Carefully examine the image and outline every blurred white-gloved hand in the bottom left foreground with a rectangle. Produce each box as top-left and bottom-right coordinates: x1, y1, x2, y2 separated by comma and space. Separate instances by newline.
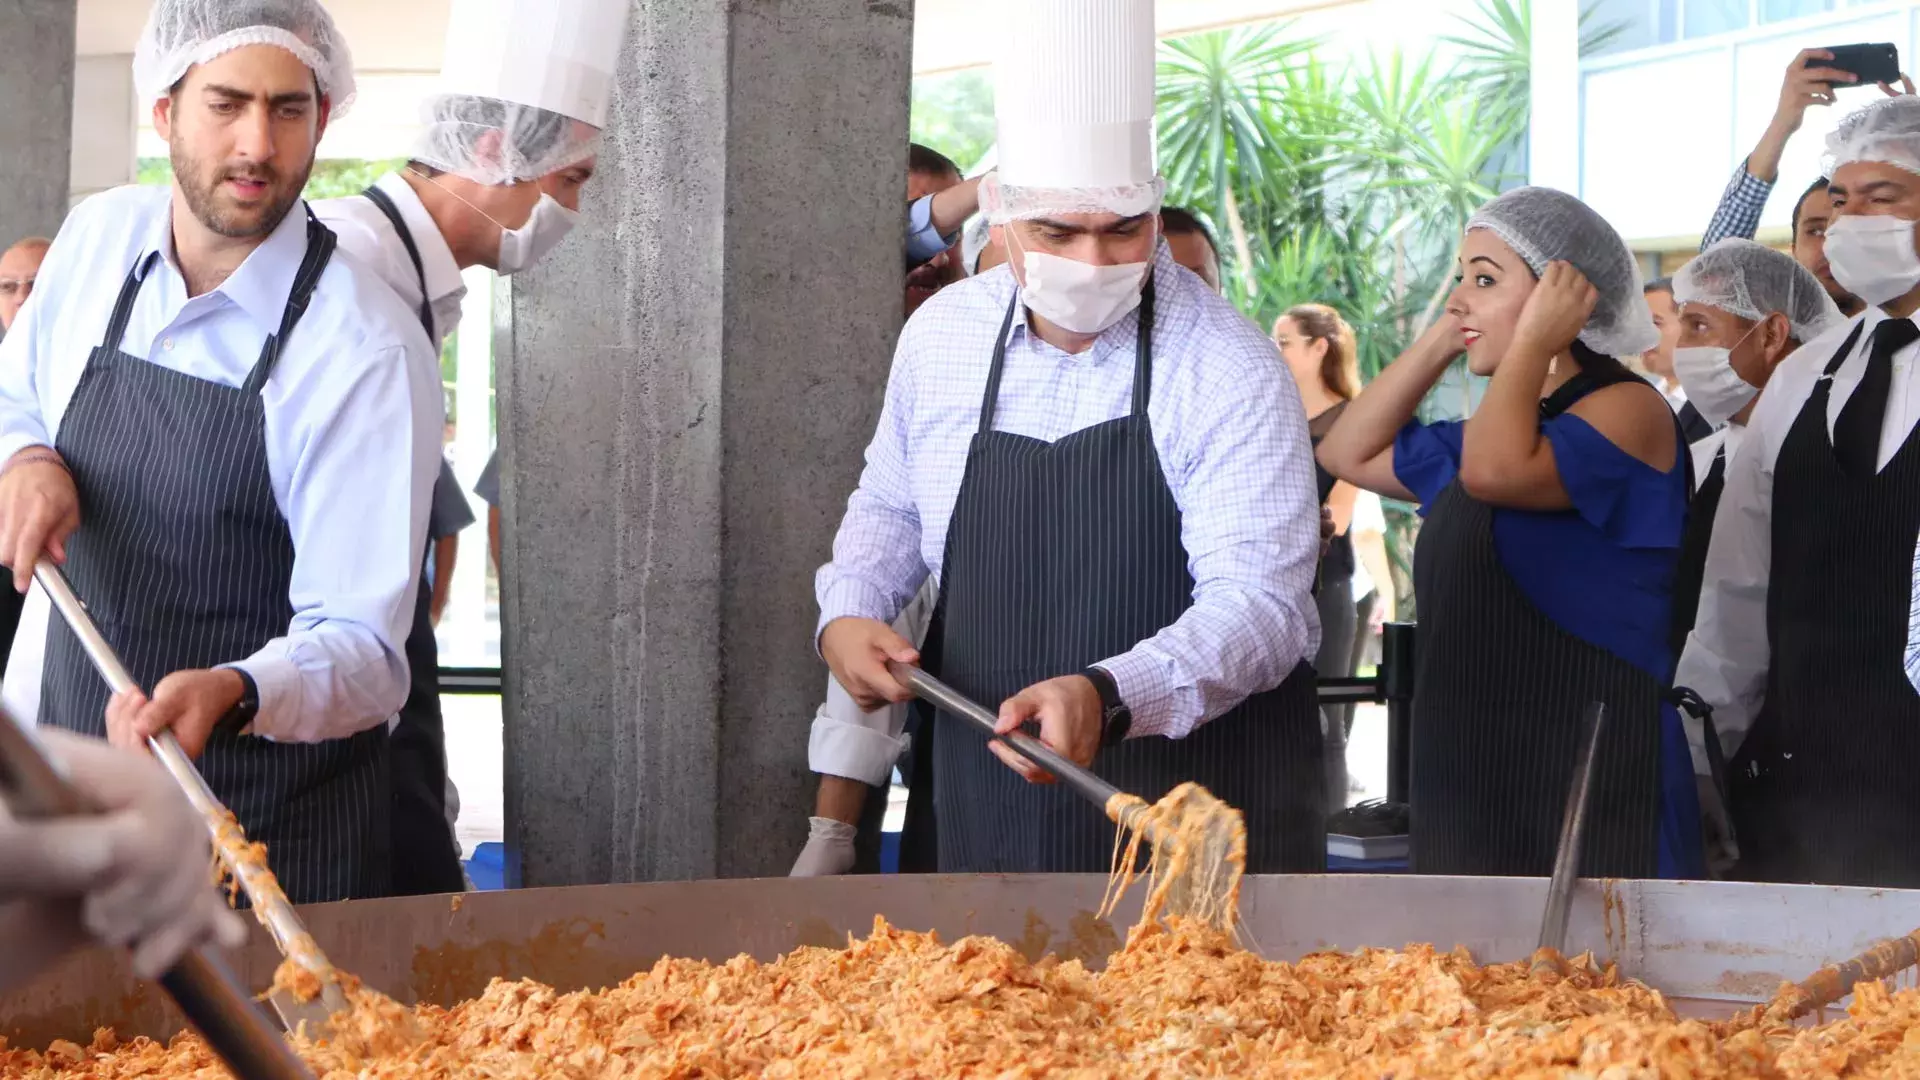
0, 728, 246, 978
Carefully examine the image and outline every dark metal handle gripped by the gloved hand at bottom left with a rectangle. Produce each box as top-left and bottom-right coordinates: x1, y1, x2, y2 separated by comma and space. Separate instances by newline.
0, 709, 313, 1080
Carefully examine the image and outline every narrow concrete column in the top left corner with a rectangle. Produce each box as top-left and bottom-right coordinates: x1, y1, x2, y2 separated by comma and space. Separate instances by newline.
0, 0, 77, 248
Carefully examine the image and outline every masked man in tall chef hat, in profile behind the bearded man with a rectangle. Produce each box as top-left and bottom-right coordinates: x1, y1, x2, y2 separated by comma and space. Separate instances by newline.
313, 0, 628, 896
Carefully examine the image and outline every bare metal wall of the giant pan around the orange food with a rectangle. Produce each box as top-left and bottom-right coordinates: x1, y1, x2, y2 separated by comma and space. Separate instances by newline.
0, 874, 1920, 1047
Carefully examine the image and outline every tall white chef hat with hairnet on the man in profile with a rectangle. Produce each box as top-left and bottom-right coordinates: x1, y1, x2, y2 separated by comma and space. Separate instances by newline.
413, 0, 630, 184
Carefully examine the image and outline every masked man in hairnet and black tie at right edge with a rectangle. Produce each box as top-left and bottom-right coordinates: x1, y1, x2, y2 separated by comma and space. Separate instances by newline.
1674, 96, 1920, 888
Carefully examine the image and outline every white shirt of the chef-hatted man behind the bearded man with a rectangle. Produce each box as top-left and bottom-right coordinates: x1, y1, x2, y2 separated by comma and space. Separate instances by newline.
313, 173, 467, 343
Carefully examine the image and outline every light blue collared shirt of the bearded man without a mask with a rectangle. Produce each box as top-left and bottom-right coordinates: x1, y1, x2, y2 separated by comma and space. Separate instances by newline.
0, 186, 445, 742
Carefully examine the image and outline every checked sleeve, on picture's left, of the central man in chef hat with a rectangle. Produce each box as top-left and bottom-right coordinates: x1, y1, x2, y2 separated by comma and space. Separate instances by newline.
814, 321, 927, 642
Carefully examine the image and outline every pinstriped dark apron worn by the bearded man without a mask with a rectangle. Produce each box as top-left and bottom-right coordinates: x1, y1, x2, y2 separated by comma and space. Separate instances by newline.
40, 213, 388, 903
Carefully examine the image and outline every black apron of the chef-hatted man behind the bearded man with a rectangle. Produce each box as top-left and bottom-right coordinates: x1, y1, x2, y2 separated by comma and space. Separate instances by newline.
361, 188, 467, 896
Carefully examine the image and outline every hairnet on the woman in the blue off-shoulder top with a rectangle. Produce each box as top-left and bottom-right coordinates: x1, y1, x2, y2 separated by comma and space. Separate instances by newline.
1467, 188, 1661, 356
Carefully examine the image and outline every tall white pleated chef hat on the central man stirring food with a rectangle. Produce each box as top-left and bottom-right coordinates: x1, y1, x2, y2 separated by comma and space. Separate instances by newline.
981, 0, 1165, 225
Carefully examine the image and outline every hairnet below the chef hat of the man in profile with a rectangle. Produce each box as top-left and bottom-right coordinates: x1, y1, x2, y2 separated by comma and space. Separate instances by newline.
413, 94, 599, 184
